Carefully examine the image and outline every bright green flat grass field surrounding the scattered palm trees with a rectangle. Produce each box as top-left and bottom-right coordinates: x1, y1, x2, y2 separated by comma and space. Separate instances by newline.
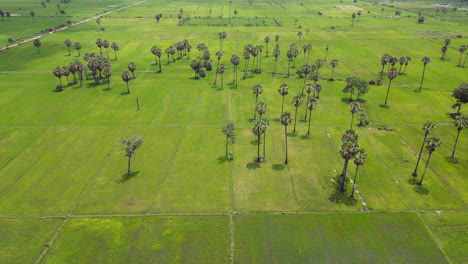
0, 0, 468, 264
